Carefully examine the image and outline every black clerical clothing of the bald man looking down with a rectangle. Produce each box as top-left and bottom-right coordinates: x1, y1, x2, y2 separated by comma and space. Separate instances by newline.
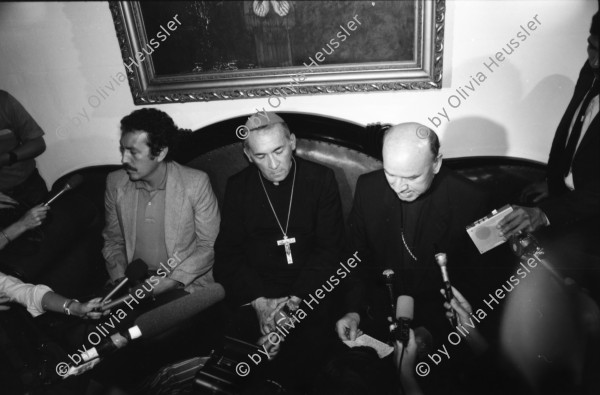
346, 166, 495, 344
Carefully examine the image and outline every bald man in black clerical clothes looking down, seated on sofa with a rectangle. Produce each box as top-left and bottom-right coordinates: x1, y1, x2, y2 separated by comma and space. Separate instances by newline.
336, 123, 487, 341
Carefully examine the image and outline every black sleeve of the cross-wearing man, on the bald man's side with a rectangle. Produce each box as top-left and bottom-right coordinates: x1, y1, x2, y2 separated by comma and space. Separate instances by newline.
290, 169, 344, 298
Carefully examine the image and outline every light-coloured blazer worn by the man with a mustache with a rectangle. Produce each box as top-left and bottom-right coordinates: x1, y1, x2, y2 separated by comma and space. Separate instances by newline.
102, 162, 221, 292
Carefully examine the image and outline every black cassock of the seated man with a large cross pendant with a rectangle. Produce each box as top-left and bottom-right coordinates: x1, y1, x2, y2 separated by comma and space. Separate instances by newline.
214, 157, 343, 390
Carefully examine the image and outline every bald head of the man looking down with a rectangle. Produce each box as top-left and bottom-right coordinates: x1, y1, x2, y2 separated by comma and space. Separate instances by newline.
383, 122, 442, 202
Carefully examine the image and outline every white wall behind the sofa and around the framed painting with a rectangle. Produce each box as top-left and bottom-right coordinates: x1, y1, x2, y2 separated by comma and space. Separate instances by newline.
0, 0, 597, 184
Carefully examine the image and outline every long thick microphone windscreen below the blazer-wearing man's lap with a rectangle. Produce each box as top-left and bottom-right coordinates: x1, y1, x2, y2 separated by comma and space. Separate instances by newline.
135, 283, 225, 337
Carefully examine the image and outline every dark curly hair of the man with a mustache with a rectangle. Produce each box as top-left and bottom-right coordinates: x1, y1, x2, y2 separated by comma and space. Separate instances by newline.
121, 108, 190, 160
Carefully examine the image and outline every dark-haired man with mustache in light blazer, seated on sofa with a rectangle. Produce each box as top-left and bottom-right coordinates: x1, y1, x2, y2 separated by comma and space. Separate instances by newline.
102, 108, 220, 295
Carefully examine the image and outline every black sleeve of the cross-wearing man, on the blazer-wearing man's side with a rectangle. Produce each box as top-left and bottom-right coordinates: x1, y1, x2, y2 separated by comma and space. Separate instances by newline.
213, 179, 264, 306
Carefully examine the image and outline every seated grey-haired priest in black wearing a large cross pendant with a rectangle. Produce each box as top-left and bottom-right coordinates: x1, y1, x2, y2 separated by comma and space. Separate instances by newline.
214, 112, 343, 392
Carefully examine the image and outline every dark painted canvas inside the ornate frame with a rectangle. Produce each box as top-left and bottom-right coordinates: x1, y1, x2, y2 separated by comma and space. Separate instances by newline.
140, 1, 417, 76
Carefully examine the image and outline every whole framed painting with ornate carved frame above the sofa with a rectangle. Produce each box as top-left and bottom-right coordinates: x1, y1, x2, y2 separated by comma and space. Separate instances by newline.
109, 0, 445, 105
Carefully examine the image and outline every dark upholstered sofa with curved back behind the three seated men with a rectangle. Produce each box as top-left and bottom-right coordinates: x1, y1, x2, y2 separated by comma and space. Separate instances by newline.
54, 113, 544, 296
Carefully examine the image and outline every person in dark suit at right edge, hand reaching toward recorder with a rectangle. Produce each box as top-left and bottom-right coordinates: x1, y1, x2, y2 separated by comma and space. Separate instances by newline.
499, 9, 600, 248
